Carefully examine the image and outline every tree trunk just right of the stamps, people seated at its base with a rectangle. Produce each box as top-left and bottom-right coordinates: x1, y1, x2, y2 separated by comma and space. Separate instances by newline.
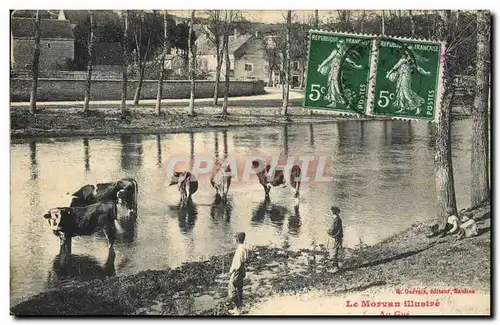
434, 11, 457, 230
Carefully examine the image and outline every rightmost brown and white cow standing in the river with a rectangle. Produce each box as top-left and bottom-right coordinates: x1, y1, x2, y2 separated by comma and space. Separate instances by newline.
252, 160, 302, 206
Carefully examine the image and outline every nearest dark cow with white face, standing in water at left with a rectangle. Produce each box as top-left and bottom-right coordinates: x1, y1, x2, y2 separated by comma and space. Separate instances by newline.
43, 202, 122, 255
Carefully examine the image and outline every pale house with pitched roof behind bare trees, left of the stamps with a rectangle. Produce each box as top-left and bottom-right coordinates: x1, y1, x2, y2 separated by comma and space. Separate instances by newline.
196, 30, 269, 80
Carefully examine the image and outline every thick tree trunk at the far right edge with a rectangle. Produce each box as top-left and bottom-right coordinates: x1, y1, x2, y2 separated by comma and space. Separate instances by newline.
471, 10, 491, 206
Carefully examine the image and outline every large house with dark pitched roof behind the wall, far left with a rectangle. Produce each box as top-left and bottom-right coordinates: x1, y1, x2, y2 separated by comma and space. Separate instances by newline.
10, 17, 75, 70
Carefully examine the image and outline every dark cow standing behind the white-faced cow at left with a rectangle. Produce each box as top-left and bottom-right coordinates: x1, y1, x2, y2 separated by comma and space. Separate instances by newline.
70, 178, 138, 213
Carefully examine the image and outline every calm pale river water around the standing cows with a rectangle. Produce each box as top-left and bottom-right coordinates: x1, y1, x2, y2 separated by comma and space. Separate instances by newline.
11, 120, 472, 303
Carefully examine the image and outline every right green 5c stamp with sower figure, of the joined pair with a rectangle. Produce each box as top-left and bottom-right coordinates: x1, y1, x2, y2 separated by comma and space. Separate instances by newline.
371, 38, 444, 120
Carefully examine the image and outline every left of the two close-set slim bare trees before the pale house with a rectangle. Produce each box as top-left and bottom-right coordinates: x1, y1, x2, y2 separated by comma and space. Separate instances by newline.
205, 10, 224, 106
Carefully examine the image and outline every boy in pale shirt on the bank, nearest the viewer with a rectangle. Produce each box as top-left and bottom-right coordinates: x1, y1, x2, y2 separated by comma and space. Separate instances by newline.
228, 232, 247, 315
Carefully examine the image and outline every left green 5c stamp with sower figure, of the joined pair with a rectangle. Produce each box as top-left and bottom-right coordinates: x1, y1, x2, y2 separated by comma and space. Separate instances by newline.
304, 31, 372, 114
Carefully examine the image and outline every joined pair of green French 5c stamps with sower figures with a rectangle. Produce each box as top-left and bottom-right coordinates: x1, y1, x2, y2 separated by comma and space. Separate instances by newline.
304, 31, 445, 120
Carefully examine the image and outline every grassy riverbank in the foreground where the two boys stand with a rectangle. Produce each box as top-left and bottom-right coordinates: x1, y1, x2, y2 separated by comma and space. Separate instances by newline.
11, 203, 491, 315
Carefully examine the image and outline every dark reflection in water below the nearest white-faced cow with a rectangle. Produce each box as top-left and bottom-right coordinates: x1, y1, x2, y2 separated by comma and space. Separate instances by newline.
47, 248, 116, 288
